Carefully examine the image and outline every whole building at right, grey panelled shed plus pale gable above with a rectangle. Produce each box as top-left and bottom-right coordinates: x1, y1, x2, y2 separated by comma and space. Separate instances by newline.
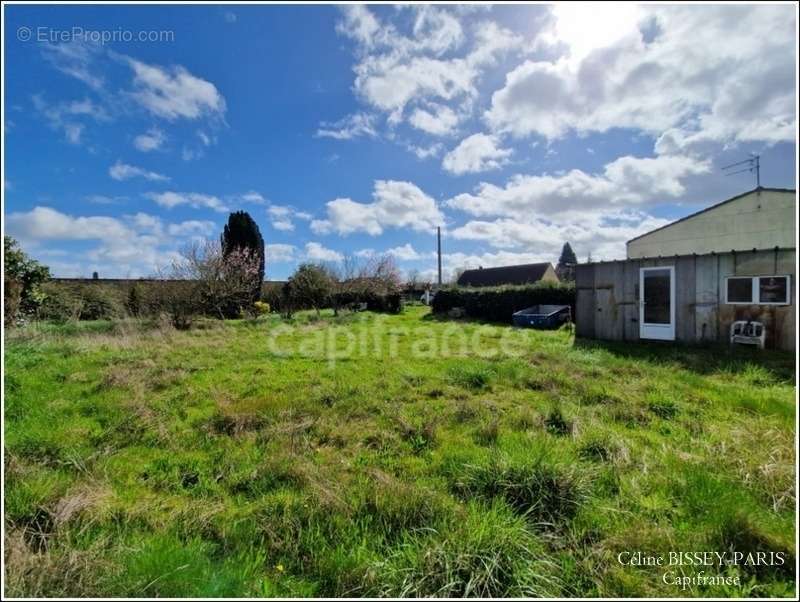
575, 188, 797, 351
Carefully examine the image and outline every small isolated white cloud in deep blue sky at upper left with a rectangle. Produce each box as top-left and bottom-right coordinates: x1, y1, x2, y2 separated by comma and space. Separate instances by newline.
126, 57, 225, 121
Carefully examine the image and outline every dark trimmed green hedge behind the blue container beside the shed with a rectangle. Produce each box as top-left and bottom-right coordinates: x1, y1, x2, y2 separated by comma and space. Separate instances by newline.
432, 283, 575, 322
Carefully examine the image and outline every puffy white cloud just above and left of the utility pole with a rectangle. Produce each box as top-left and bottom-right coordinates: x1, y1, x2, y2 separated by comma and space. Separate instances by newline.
311, 180, 444, 236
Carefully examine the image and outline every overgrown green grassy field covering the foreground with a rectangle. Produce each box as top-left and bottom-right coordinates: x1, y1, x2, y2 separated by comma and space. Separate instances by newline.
5, 307, 796, 597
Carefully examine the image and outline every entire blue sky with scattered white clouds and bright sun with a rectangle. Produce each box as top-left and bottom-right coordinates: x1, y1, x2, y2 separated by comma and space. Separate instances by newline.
3, 3, 797, 280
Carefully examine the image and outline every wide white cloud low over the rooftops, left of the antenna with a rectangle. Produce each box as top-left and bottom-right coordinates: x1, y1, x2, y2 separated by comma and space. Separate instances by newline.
446, 151, 710, 261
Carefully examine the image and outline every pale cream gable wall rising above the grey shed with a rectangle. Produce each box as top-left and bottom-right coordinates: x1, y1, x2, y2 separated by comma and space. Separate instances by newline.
628, 189, 797, 259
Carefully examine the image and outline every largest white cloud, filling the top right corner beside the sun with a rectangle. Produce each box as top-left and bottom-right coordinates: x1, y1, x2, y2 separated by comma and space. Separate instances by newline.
485, 5, 797, 152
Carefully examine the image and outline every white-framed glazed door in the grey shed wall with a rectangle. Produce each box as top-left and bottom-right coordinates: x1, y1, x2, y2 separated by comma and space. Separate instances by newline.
639, 265, 675, 341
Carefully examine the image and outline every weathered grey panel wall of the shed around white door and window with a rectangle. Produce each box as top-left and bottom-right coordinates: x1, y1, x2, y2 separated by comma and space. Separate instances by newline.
575, 249, 797, 351
